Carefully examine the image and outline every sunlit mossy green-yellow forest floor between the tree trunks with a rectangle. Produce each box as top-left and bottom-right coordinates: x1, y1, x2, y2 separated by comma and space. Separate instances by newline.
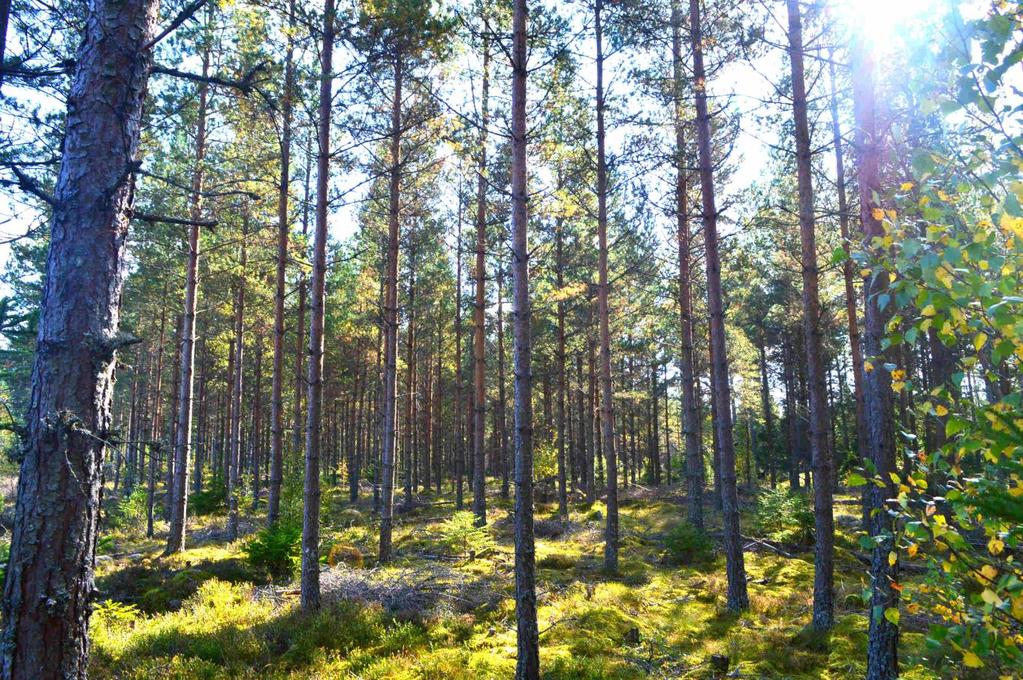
83, 480, 941, 680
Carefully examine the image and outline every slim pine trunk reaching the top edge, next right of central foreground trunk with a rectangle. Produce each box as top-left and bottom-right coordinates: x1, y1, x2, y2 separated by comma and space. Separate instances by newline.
593, 0, 618, 573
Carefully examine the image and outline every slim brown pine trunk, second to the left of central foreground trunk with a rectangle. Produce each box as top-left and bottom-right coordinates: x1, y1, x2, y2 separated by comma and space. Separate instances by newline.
380, 56, 403, 562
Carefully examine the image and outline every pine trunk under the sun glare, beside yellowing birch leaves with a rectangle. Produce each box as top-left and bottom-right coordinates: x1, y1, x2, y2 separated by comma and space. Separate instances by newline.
851, 35, 898, 680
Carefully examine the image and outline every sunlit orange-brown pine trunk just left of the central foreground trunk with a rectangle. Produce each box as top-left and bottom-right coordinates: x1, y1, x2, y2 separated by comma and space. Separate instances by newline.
473, 37, 490, 527
